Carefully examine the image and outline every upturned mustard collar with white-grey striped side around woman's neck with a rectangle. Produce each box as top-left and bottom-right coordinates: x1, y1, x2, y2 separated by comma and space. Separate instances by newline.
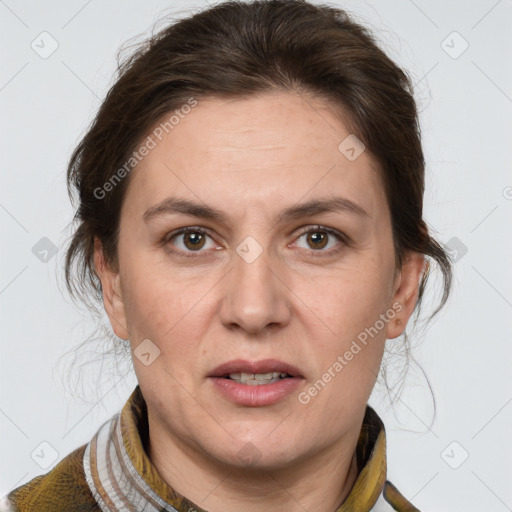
84, 386, 386, 512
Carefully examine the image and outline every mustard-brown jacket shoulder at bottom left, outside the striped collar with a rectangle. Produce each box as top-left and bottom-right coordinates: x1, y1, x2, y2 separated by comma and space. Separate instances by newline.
0, 445, 100, 512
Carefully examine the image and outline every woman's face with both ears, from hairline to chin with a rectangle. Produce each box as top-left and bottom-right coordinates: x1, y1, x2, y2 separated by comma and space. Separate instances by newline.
96, 92, 422, 469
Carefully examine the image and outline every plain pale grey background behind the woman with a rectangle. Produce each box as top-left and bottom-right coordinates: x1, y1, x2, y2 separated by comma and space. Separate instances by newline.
0, 0, 512, 512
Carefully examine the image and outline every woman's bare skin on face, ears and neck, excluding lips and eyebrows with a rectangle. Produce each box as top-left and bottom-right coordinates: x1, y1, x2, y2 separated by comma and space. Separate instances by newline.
95, 92, 424, 512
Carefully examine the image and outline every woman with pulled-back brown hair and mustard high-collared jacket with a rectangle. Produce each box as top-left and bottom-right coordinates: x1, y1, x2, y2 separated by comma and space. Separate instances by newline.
5, 0, 451, 512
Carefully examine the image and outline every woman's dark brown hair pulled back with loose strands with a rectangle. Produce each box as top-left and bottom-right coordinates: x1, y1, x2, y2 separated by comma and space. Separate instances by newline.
65, 0, 452, 336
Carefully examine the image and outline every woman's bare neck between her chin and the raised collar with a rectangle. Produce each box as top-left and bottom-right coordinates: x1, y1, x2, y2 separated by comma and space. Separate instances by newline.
148, 421, 359, 512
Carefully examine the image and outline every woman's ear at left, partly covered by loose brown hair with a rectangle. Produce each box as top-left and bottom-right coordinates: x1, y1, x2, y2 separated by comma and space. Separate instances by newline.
94, 237, 129, 340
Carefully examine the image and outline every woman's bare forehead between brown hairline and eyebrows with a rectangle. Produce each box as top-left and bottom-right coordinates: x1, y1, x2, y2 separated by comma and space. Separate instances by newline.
125, 92, 384, 219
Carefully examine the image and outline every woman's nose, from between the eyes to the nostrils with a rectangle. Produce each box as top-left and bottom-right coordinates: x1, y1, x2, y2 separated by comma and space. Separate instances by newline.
220, 242, 292, 334
